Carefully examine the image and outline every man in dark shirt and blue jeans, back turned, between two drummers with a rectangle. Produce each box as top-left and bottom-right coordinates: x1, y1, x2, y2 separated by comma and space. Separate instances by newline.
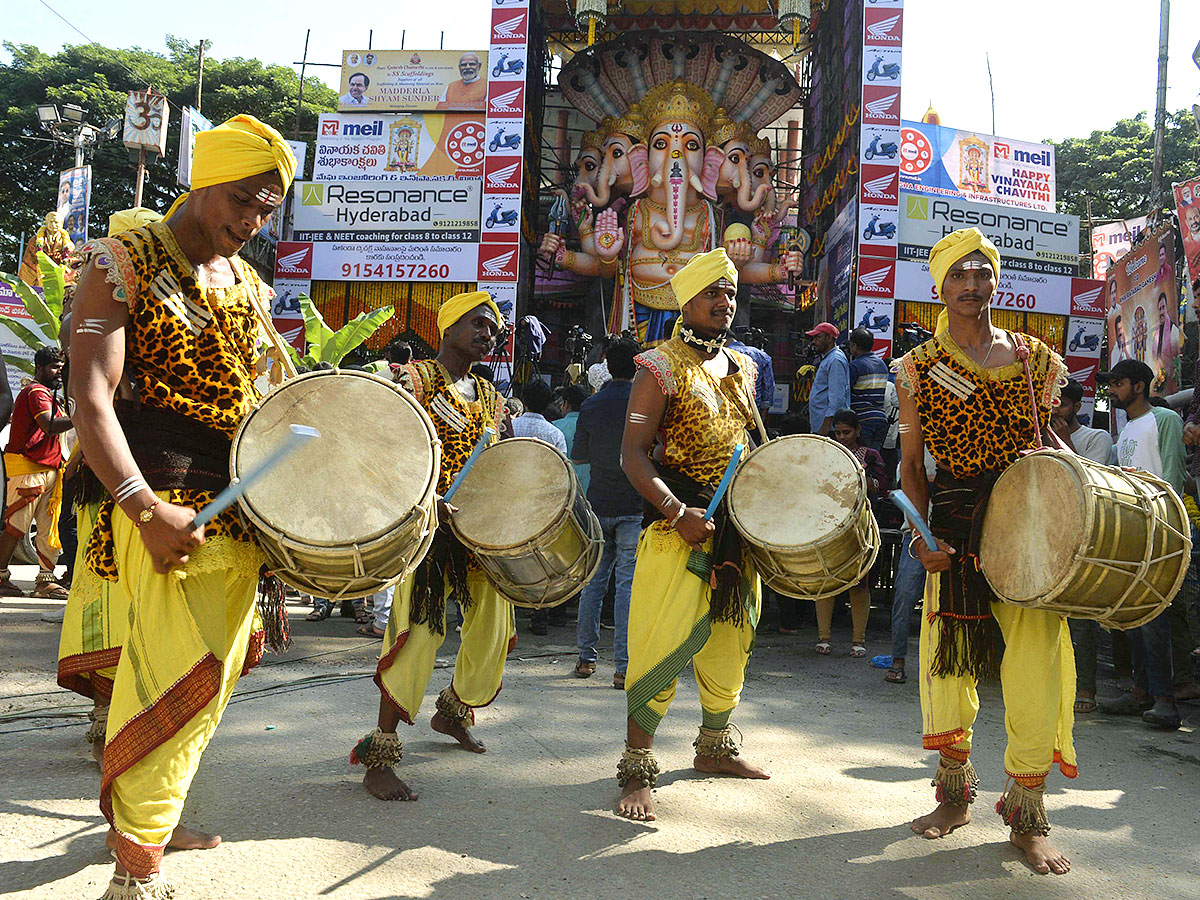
571, 337, 642, 690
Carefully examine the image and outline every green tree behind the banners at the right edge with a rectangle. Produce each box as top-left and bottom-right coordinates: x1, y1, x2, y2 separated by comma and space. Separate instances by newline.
1055, 109, 1200, 230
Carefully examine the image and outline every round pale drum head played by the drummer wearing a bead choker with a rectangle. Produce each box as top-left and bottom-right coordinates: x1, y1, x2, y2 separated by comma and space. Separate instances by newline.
728, 434, 865, 547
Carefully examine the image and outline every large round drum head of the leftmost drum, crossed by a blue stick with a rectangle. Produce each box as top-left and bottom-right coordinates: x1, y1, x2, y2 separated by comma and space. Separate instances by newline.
230, 372, 438, 546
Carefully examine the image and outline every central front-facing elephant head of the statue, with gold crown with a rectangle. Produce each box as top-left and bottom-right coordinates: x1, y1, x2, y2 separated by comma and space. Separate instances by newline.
642, 79, 720, 250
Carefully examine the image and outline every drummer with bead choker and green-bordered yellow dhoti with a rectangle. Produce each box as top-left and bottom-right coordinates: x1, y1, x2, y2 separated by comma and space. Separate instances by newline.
617, 248, 770, 821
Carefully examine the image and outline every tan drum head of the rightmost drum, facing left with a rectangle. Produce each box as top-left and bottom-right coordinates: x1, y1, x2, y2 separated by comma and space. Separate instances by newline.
979, 452, 1088, 601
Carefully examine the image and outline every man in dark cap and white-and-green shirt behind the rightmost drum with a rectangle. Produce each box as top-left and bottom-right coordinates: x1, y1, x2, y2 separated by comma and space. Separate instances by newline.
1102, 359, 1186, 730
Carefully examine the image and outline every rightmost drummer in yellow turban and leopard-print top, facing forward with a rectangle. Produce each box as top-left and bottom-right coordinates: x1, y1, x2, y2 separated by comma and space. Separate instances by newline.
894, 228, 1076, 875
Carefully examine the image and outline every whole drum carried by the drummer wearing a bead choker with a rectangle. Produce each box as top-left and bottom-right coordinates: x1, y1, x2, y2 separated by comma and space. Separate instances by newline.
728, 434, 880, 600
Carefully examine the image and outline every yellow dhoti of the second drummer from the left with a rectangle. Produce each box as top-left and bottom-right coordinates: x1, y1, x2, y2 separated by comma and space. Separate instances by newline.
374, 570, 516, 725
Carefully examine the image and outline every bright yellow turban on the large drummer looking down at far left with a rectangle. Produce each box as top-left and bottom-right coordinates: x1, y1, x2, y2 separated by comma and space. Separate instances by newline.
166, 115, 296, 218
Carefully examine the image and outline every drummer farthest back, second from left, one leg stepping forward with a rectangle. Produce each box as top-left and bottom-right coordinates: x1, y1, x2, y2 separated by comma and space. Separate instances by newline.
350, 290, 516, 800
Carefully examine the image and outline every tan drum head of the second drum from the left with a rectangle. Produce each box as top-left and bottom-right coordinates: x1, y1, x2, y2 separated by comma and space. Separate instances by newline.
452, 438, 575, 550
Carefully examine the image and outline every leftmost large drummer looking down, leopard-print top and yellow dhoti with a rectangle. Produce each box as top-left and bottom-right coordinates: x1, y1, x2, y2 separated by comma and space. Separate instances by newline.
71, 115, 296, 900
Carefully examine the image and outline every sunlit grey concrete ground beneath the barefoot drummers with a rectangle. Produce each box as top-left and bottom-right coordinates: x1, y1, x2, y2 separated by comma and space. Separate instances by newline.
0, 570, 1200, 900
